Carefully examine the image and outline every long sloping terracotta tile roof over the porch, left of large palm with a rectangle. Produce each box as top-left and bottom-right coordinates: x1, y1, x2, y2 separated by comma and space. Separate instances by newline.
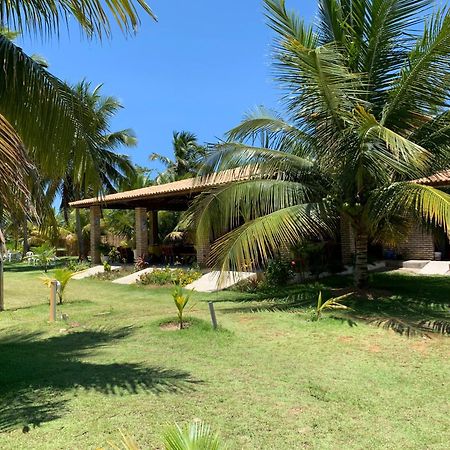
70, 168, 251, 208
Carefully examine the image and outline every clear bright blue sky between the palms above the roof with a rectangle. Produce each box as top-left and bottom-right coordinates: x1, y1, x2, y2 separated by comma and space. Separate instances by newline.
20, 0, 316, 175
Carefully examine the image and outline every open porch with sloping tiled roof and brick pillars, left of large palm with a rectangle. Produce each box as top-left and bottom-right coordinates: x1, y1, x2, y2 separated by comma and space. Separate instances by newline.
70, 170, 244, 266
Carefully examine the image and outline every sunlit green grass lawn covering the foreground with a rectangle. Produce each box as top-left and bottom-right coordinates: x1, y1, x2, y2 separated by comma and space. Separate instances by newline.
0, 271, 450, 449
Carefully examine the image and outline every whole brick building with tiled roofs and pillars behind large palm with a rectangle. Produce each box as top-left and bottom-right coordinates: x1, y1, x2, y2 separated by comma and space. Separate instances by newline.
71, 169, 450, 264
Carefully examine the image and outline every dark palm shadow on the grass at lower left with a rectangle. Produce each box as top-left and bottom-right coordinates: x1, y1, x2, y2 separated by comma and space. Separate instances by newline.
0, 328, 200, 431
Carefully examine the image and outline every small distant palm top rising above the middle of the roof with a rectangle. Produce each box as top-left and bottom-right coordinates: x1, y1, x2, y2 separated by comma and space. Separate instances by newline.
150, 131, 206, 184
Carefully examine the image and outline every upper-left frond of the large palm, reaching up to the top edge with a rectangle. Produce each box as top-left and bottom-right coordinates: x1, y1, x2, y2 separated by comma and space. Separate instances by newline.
266, 0, 365, 128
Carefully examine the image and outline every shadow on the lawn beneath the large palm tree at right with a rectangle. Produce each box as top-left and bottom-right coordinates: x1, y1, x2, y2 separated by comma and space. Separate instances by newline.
222, 273, 450, 336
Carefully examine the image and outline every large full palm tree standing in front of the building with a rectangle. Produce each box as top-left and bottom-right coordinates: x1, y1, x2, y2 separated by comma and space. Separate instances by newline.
188, 0, 450, 287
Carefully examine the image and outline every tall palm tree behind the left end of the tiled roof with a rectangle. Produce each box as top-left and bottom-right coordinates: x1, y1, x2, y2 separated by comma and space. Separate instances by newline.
47, 81, 137, 257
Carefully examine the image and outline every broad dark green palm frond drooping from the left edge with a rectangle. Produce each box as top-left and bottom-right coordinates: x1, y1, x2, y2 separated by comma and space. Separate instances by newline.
0, 35, 102, 182
